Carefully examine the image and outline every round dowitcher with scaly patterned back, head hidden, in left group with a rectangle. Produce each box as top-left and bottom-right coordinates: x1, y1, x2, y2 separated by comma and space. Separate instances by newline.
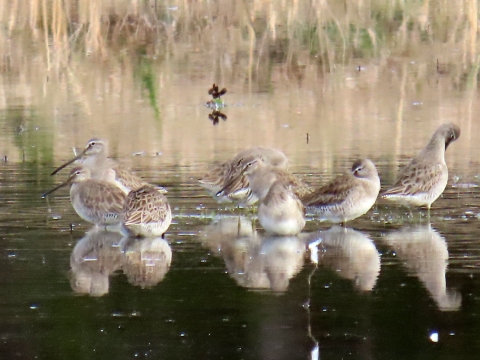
123, 185, 172, 237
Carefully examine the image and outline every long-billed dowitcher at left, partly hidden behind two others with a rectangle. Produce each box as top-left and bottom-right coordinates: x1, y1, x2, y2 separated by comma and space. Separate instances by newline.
51, 138, 147, 194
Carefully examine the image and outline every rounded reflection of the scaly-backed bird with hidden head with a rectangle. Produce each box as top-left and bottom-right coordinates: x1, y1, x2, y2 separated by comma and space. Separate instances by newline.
123, 237, 172, 288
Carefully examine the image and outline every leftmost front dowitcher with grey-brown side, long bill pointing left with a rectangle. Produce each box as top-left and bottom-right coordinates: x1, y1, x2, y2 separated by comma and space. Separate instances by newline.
42, 166, 125, 225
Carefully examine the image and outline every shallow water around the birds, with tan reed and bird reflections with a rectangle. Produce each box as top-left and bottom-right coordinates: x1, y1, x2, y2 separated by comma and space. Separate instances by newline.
0, 1, 480, 359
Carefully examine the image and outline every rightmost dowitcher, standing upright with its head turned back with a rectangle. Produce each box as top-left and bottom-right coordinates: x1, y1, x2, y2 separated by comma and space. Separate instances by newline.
382, 123, 460, 210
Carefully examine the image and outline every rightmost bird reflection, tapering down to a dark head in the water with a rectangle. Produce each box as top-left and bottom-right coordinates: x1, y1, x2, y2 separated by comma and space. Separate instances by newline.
383, 225, 462, 311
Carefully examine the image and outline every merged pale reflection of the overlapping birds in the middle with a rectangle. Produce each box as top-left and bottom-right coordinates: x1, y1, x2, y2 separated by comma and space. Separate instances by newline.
202, 217, 304, 292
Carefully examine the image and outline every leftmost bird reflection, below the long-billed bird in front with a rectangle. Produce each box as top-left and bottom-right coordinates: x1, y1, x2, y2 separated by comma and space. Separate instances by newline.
70, 227, 123, 296
